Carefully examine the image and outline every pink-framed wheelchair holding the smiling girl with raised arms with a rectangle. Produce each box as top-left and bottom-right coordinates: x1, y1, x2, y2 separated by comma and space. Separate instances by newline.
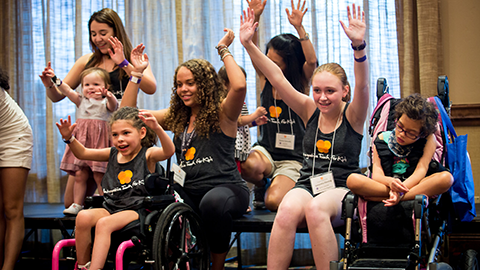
52, 159, 210, 270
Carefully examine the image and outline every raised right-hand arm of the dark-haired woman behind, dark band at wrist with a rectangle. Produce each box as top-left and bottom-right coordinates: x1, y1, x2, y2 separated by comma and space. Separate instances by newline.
285, 0, 317, 85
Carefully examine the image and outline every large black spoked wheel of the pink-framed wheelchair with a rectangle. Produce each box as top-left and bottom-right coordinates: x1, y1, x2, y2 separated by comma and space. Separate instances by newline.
152, 202, 209, 270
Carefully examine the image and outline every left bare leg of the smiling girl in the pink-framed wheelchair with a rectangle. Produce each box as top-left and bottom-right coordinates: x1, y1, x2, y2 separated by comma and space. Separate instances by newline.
75, 208, 110, 265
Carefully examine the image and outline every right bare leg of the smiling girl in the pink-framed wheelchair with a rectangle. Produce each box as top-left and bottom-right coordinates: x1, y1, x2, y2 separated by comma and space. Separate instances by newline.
90, 210, 138, 270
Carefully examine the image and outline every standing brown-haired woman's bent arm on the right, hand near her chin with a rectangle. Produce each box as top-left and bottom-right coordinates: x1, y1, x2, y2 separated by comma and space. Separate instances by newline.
108, 36, 157, 95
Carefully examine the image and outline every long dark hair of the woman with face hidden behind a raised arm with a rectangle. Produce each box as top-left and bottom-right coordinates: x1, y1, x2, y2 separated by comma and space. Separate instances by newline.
265, 34, 308, 93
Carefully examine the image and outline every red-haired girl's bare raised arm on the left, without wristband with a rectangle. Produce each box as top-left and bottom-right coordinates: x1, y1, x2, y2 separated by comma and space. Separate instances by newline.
240, 9, 316, 123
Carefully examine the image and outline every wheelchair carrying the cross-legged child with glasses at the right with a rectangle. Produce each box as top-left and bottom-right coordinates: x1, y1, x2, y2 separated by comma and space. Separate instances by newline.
330, 76, 478, 270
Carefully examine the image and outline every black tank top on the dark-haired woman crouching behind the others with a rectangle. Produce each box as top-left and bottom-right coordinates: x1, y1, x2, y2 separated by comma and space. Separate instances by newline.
258, 81, 305, 162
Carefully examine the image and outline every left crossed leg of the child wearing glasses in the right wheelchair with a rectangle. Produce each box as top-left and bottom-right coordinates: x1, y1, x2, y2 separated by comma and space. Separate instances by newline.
347, 173, 390, 198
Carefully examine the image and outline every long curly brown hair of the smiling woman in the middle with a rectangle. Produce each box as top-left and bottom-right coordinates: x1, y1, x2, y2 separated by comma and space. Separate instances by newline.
165, 59, 227, 138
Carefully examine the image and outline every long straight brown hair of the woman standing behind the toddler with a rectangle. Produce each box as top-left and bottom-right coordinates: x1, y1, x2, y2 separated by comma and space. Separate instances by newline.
85, 8, 133, 79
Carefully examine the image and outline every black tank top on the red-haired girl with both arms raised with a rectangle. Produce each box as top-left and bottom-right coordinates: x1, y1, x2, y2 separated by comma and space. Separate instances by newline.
297, 104, 363, 190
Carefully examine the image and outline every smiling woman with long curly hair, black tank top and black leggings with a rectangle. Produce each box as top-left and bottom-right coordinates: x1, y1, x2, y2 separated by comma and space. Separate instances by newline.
122, 29, 249, 269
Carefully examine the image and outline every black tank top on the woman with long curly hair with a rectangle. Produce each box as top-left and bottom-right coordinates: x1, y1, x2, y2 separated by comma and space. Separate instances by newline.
174, 132, 248, 195
